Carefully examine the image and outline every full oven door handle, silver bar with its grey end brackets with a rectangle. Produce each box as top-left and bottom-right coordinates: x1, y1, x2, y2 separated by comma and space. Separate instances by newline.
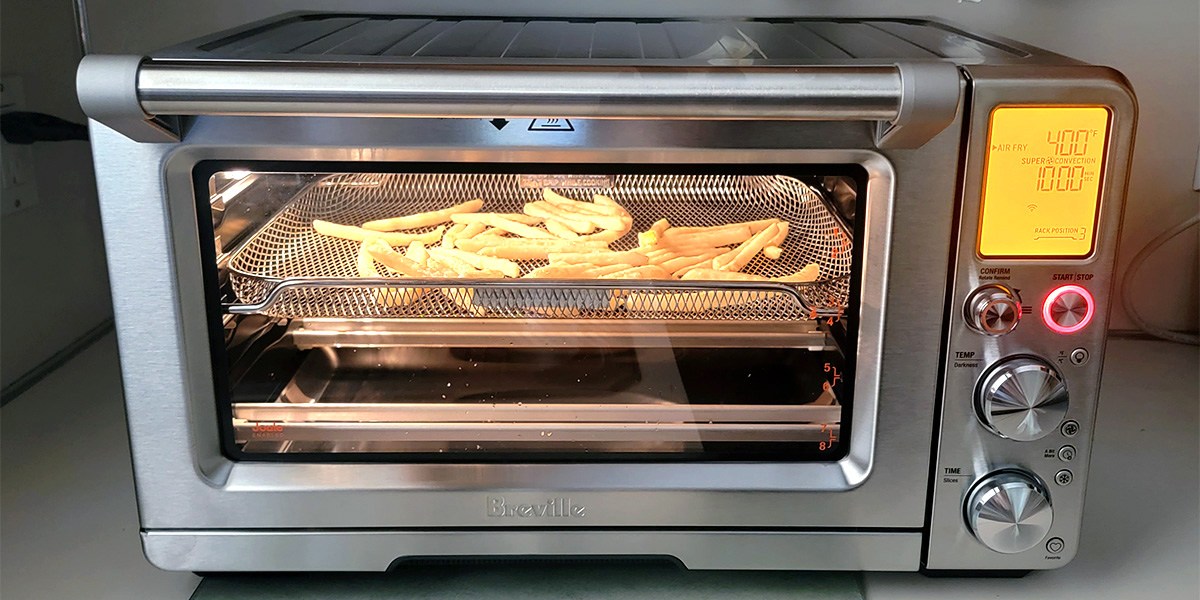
77, 55, 961, 148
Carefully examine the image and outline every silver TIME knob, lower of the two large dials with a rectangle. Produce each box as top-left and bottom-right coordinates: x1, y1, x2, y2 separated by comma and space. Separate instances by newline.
966, 470, 1054, 554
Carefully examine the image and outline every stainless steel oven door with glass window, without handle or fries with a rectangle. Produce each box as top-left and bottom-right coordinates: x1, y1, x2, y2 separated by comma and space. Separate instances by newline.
84, 71, 960, 570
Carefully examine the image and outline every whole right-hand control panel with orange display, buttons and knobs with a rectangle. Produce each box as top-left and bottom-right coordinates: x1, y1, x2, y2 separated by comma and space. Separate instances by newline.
923, 73, 1132, 572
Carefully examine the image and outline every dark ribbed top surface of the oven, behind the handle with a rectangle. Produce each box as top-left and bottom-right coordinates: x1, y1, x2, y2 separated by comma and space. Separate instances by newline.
154, 13, 1064, 67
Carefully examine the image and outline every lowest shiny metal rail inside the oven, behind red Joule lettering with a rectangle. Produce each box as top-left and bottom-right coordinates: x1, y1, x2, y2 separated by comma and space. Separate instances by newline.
233, 403, 841, 443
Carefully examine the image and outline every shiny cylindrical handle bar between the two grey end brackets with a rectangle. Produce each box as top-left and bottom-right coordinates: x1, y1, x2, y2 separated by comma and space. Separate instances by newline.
137, 61, 901, 120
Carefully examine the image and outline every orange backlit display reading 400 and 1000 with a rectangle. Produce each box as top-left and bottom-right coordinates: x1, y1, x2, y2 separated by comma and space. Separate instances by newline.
979, 107, 1109, 258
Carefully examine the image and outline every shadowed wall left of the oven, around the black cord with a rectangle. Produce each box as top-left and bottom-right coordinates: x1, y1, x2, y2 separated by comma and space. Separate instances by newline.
0, 0, 112, 385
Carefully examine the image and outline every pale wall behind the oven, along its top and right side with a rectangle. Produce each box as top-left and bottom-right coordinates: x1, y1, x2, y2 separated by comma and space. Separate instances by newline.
84, 0, 1200, 330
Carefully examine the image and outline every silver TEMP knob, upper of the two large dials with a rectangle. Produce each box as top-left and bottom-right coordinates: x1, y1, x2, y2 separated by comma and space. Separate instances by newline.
976, 356, 1069, 442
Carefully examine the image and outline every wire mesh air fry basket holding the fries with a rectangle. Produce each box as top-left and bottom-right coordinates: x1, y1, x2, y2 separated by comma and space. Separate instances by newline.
228, 173, 853, 320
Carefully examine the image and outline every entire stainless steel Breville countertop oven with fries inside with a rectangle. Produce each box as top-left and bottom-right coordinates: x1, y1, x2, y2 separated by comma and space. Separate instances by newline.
79, 14, 1136, 572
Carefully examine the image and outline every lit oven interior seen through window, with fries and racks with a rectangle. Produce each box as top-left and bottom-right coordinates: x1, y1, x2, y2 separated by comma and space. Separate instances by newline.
201, 162, 866, 462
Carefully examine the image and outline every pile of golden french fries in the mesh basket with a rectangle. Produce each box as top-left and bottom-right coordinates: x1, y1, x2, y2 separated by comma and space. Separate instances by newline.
304, 188, 820, 314
